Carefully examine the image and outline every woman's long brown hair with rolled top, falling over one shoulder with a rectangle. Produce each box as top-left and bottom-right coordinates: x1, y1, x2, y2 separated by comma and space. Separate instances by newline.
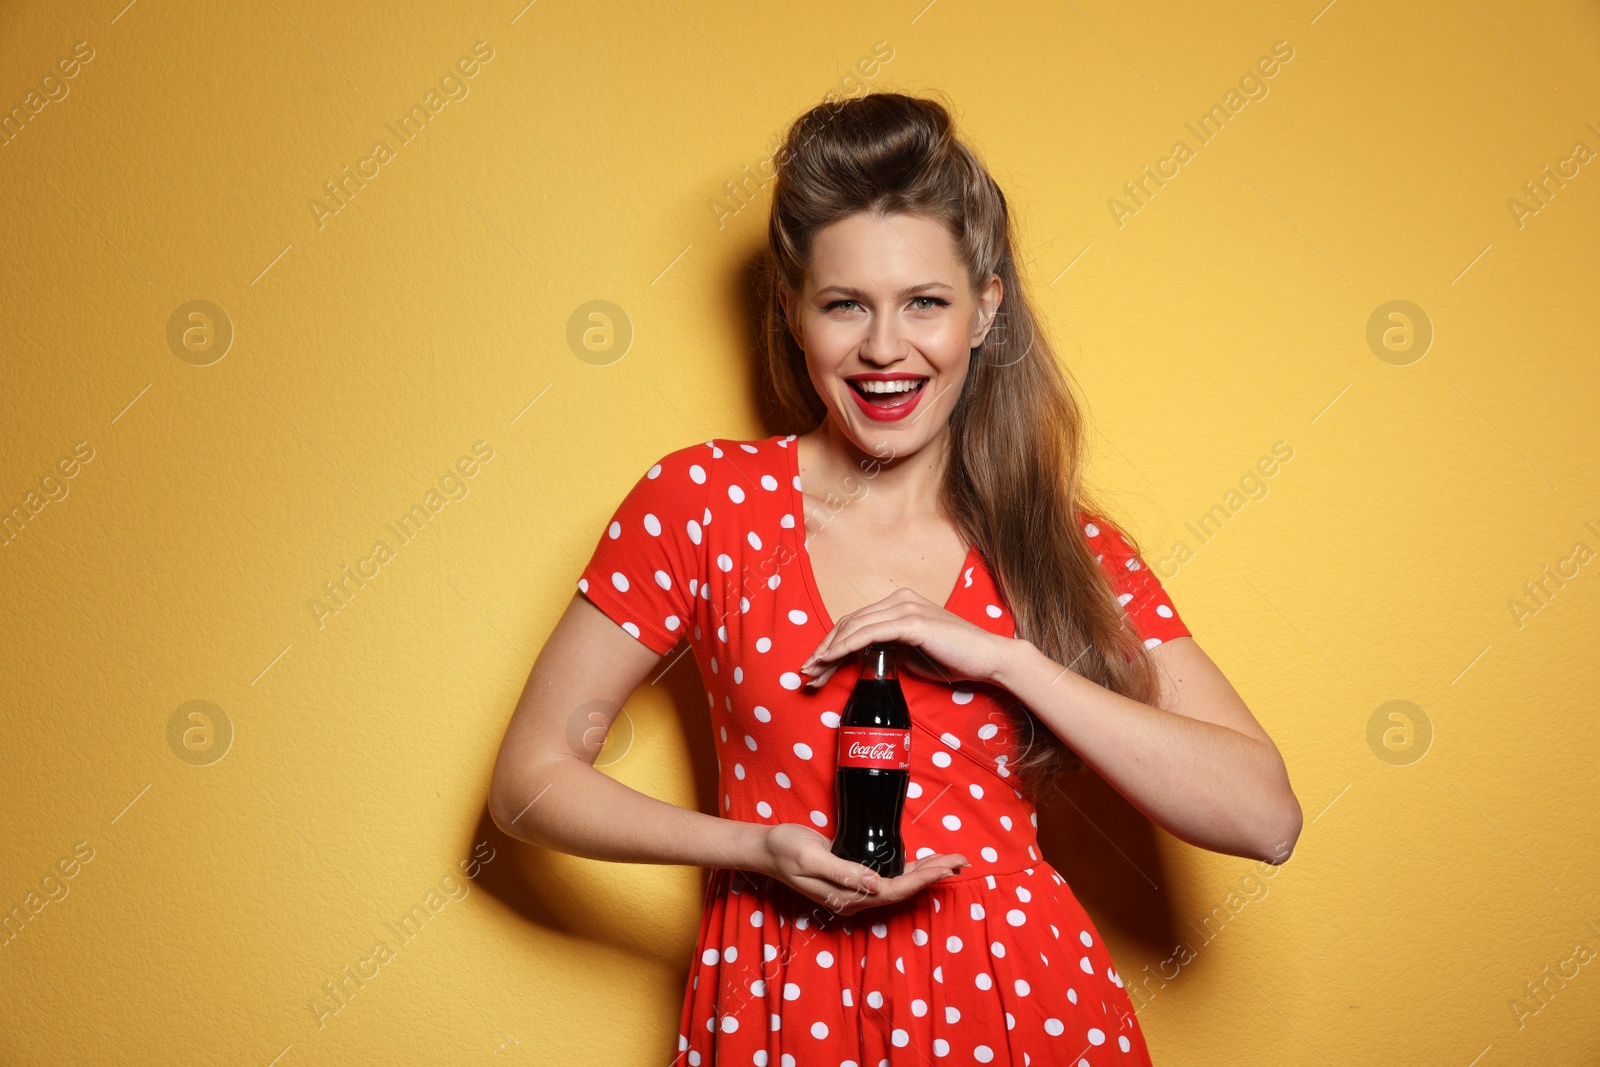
760, 93, 1158, 798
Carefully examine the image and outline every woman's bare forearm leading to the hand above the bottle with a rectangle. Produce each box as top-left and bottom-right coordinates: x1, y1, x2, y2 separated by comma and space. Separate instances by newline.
995, 640, 1299, 864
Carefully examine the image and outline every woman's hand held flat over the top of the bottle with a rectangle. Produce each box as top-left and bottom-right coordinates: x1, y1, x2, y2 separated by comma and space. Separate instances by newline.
800, 587, 1014, 688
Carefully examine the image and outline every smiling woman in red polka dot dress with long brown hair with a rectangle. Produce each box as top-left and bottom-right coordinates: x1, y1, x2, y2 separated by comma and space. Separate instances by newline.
491, 93, 1301, 1067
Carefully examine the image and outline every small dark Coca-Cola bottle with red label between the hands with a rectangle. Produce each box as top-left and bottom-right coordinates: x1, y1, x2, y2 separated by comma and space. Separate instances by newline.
834, 643, 910, 878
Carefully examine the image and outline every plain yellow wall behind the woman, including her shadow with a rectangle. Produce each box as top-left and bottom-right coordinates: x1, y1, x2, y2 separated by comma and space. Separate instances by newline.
0, 0, 1600, 1067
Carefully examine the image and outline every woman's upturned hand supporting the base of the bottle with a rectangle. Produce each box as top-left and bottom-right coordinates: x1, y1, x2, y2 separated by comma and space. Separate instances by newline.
762, 822, 966, 915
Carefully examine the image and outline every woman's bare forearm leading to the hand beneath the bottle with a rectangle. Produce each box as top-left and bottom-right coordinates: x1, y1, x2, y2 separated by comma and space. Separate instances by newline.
490, 757, 766, 870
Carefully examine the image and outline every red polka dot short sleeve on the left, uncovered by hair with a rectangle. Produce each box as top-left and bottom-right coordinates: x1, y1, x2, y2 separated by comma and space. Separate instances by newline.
578, 446, 710, 654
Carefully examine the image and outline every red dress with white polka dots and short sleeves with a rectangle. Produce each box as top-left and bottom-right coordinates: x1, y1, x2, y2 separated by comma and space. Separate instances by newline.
578, 435, 1189, 1067
